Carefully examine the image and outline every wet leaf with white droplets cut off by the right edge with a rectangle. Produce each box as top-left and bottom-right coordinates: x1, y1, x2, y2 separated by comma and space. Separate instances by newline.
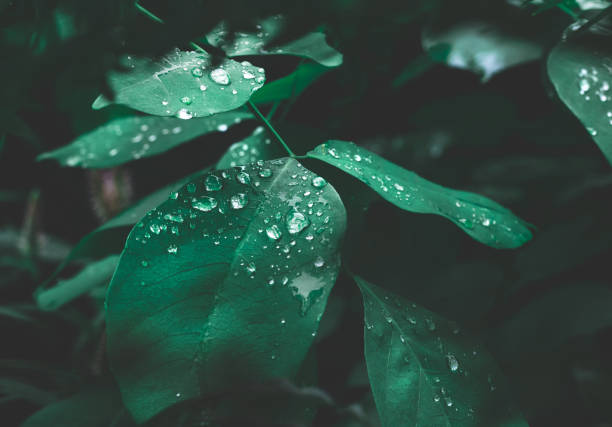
546, 35, 612, 163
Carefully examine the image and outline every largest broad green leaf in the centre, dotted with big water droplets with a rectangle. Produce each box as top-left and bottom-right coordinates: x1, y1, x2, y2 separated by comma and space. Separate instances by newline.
106, 159, 346, 422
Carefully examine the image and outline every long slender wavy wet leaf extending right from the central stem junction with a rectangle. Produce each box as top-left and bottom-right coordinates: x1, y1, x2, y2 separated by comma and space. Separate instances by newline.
307, 141, 531, 249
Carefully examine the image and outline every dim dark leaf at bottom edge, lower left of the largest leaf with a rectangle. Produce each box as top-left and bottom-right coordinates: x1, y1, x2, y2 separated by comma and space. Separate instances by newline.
21, 385, 136, 427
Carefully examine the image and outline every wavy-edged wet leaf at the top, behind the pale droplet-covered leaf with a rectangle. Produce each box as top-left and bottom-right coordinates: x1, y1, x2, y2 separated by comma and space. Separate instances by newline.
206, 15, 342, 67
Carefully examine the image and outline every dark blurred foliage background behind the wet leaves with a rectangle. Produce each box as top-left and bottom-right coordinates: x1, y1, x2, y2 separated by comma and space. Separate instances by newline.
0, 0, 612, 426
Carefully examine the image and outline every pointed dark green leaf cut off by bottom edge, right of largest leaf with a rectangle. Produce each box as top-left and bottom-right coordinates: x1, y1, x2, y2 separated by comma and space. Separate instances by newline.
355, 277, 527, 427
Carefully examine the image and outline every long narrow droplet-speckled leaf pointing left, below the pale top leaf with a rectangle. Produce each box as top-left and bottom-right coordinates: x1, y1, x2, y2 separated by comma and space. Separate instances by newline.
38, 111, 252, 168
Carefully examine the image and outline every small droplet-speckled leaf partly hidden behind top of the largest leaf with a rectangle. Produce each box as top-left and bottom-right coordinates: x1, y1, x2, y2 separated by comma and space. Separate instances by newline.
216, 126, 283, 169
